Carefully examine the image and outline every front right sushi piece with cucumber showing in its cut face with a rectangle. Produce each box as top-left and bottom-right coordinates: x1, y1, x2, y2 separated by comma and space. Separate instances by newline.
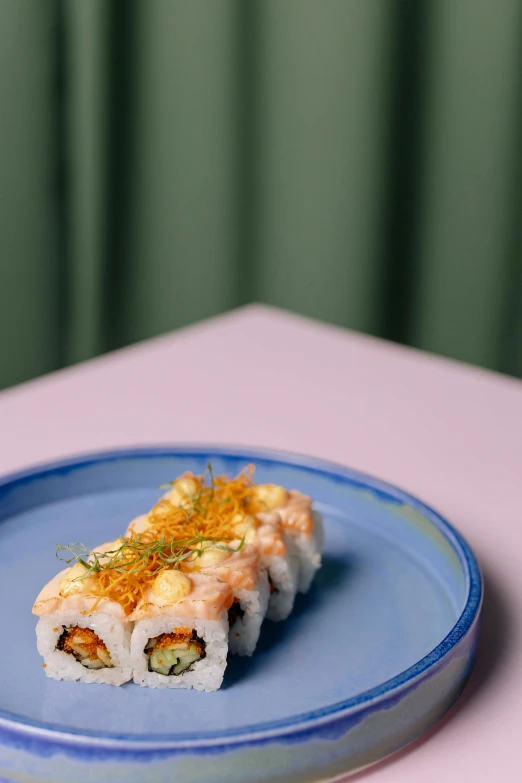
131, 568, 233, 691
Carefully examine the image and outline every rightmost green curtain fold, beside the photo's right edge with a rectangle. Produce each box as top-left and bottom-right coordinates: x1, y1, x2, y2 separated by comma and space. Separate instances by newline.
411, 0, 522, 371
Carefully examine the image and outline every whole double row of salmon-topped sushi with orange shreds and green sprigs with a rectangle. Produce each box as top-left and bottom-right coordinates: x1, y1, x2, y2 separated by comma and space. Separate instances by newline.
33, 466, 323, 691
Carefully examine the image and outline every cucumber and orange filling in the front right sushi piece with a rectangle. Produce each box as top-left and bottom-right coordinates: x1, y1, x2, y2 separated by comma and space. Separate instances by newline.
144, 628, 205, 676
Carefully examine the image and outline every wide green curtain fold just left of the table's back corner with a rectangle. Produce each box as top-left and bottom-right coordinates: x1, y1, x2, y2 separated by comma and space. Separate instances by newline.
114, 0, 240, 350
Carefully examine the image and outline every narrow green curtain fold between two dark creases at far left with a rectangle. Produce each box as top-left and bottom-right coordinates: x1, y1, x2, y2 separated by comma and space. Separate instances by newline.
61, 0, 113, 362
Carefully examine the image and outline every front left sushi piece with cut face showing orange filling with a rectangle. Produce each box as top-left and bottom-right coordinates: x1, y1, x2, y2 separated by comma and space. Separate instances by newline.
33, 544, 132, 685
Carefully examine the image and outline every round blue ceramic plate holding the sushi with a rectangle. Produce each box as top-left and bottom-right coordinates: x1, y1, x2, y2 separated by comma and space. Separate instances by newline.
0, 446, 482, 783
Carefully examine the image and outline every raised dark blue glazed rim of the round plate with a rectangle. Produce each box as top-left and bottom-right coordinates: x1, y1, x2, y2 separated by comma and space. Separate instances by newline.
0, 442, 484, 752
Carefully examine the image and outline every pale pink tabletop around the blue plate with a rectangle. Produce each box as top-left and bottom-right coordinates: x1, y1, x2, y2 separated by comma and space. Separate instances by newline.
0, 305, 522, 783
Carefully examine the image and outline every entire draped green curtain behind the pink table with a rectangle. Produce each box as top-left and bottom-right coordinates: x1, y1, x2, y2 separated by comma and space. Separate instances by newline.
0, 0, 522, 386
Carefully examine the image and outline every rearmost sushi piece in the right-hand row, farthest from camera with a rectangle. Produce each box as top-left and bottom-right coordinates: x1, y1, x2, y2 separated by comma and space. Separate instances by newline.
254, 484, 324, 593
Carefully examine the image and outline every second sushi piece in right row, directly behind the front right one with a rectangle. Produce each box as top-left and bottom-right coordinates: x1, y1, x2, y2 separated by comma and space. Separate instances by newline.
180, 540, 270, 655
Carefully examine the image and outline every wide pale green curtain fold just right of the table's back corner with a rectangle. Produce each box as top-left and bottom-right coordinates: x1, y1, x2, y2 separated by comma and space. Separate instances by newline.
255, 0, 393, 331
